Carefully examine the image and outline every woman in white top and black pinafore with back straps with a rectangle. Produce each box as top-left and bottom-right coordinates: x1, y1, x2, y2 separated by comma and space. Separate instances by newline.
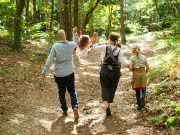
92, 32, 129, 116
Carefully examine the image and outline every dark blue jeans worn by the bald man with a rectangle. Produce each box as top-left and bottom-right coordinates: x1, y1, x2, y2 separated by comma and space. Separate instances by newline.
54, 73, 78, 112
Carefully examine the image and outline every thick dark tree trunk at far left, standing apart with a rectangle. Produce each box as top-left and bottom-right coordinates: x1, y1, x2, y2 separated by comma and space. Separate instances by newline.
13, 0, 25, 51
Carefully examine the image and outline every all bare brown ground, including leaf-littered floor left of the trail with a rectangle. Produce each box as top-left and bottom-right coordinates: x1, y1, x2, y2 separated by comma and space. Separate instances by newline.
0, 36, 179, 135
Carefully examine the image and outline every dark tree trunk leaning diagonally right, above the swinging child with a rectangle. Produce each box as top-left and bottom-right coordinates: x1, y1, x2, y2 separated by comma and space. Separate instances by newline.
83, 0, 100, 29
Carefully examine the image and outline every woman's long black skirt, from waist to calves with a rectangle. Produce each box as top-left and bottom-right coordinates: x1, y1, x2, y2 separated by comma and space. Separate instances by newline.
100, 64, 121, 103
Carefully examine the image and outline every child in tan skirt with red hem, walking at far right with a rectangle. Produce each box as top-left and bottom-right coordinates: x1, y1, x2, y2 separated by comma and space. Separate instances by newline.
130, 45, 149, 110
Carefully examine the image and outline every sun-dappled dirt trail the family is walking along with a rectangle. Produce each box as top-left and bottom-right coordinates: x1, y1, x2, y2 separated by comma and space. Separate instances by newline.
0, 34, 169, 135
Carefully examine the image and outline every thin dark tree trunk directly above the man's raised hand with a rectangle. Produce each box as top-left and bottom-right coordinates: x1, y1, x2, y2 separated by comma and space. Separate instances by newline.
74, 0, 79, 29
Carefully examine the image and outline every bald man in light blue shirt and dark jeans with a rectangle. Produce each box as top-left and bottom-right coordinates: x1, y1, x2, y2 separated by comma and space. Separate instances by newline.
42, 28, 79, 120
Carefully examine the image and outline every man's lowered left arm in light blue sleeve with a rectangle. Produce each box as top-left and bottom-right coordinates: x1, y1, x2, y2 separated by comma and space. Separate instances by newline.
41, 47, 55, 76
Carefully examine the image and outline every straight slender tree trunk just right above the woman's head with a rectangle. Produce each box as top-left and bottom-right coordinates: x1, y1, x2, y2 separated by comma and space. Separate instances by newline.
120, 0, 126, 44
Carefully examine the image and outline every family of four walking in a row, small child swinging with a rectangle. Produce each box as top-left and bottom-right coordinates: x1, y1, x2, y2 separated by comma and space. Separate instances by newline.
42, 28, 149, 121
